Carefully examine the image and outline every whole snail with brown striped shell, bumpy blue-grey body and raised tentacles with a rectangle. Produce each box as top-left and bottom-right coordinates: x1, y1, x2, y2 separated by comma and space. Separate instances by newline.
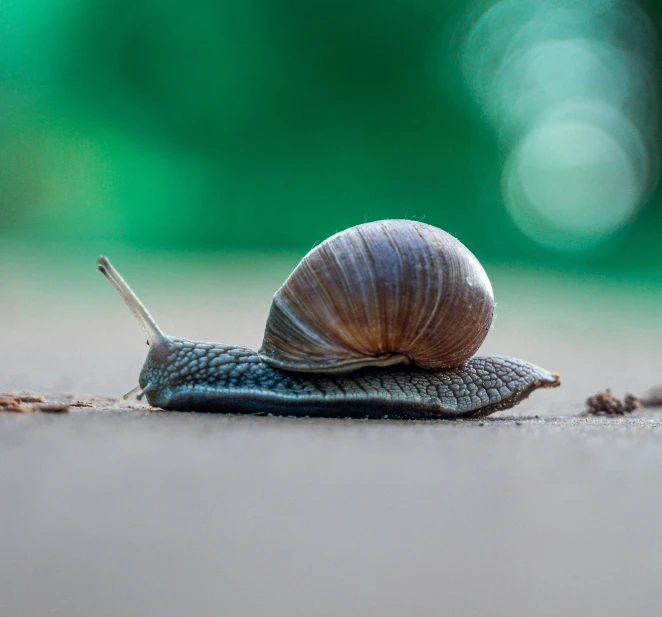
98, 220, 560, 419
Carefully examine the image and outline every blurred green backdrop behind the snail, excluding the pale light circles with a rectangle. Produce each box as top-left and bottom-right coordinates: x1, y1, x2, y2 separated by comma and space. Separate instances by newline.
0, 0, 662, 271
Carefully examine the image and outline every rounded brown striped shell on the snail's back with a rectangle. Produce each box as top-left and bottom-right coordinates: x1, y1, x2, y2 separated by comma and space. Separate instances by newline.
259, 220, 494, 372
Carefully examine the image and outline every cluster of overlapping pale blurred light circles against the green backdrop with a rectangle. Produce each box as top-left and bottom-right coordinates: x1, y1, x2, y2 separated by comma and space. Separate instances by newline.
463, 0, 659, 250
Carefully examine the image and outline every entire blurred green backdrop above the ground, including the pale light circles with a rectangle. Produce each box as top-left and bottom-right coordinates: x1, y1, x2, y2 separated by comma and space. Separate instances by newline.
0, 0, 662, 270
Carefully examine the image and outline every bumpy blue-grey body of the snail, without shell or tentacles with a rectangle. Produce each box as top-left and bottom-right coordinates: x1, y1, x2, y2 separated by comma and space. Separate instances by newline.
140, 338, 560, 419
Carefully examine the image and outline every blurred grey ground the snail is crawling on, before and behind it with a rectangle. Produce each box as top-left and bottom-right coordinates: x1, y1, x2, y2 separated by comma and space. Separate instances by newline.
0, 248, 662, 617
